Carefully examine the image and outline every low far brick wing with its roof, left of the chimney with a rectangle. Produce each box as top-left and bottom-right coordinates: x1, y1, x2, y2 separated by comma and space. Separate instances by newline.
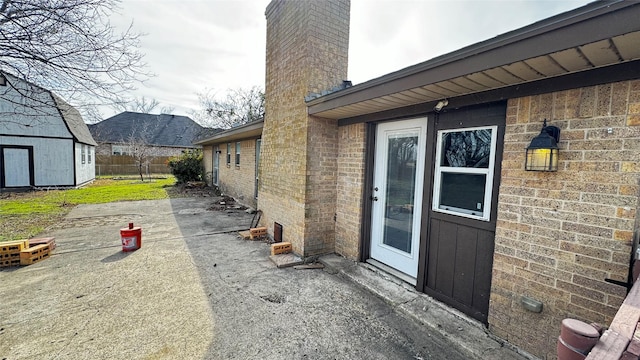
195, 120, 264, 208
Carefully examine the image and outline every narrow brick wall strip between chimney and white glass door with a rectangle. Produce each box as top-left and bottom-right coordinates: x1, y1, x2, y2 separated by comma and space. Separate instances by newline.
335, 124, 366, 260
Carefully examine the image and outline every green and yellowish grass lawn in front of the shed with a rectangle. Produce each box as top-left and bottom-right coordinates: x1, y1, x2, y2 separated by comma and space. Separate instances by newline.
0, 176, 175, 241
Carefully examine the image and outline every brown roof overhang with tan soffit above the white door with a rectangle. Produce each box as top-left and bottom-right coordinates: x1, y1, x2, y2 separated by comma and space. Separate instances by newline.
307, 0, 640, 120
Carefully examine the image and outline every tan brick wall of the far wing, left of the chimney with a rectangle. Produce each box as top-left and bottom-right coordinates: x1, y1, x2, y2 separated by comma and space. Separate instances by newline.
218, 139, 257, 208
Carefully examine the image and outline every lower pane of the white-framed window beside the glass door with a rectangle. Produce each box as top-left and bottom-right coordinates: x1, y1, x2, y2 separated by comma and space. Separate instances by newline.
440, 172, 487, 215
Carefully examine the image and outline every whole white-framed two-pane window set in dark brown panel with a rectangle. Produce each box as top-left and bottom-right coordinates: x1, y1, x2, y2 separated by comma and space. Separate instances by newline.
433, 126, 498, 221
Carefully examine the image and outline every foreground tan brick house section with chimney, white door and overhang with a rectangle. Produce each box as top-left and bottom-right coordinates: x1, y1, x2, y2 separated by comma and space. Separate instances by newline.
205, 0, 640, 358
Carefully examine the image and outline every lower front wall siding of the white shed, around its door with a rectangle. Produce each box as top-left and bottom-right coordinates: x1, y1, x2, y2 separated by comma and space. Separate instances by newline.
0, 136, 74, 186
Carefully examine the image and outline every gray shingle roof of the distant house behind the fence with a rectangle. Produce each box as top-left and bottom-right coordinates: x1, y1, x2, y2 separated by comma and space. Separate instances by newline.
89, 111, 202, 147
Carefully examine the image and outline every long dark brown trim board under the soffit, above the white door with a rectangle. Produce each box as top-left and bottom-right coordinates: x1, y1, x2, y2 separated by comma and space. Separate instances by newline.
338, 60, 640, 126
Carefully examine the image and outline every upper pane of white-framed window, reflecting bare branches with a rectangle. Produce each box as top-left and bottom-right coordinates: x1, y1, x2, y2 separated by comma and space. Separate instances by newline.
440, 129, 492, 169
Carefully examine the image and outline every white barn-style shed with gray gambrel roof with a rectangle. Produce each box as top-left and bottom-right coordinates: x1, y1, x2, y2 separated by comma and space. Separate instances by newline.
0, 74, 96, 189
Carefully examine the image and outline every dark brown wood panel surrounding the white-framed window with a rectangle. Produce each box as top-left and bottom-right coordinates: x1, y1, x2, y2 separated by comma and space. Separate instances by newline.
418, 102, 506, 323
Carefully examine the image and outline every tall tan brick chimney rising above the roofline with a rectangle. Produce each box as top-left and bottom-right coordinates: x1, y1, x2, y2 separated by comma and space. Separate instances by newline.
258, 0, 350, 256
